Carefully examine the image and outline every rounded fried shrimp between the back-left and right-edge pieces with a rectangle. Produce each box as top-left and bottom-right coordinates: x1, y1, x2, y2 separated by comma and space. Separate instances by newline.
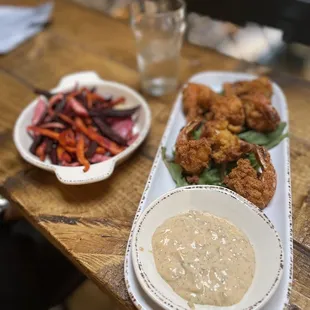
207, 95, 245, 133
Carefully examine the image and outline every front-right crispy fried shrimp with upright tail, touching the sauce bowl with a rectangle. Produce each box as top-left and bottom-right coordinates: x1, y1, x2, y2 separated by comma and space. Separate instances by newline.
224, 147, 277, 209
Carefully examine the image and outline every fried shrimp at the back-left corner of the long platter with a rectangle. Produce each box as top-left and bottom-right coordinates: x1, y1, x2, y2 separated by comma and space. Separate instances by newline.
183, 83, 214, 122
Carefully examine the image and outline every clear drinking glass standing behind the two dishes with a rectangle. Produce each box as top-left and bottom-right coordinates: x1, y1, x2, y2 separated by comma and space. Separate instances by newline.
130, 0, 186, 96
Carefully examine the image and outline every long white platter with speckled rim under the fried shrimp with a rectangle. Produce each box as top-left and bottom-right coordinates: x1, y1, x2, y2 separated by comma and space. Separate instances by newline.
125, 72, 293, 310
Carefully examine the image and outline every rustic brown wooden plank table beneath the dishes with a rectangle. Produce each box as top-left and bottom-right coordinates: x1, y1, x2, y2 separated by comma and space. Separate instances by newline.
0, 0, 310, 310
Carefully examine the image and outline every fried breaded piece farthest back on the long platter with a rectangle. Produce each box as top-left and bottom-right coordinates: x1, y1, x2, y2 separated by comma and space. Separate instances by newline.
224, 77, 272, 98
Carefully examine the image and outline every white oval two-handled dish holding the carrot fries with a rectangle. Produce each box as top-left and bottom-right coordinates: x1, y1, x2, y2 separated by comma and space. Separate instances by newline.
14, 71, 151, 185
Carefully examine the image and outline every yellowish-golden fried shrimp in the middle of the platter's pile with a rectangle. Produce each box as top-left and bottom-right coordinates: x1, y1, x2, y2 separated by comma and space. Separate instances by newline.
203, 121, 253, 164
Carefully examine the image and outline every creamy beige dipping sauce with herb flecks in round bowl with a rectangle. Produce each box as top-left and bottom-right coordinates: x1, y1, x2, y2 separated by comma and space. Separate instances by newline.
152, 211, 255, 307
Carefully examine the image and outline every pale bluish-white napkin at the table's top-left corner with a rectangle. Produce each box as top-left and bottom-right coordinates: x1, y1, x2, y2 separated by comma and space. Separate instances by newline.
0, 2, 54, 54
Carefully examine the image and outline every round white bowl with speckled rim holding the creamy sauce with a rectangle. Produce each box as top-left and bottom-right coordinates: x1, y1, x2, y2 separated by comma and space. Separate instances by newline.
132, 186, 283, 310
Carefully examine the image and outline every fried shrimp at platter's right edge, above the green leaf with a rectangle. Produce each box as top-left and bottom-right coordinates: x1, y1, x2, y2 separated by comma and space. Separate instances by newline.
242, 94, 280, 132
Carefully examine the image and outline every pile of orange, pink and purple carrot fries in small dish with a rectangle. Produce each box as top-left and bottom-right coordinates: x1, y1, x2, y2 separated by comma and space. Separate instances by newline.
27, 84, 134, 171
